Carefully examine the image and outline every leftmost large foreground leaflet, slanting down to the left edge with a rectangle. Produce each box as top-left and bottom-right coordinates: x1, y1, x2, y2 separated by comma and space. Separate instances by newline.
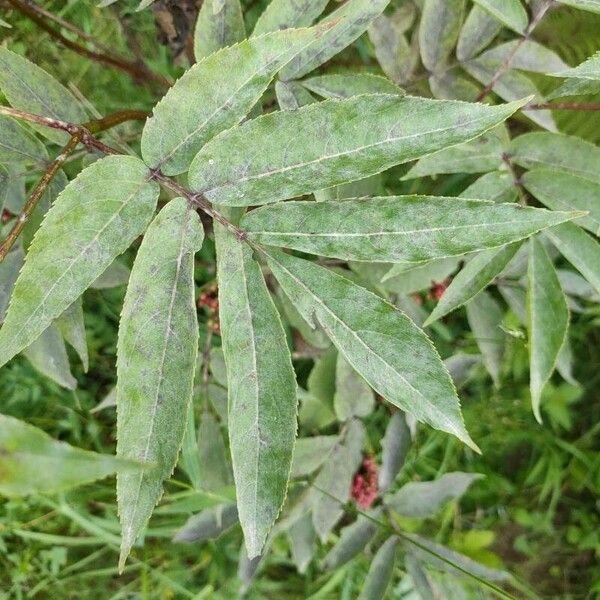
0, 156, 159, 366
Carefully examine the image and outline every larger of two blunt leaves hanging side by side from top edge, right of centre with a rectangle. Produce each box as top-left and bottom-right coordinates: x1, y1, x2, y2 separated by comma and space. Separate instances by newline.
419, 0, 465, 71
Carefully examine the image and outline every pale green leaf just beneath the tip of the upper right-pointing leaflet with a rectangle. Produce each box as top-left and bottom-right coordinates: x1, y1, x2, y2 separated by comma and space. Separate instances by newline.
402, 125, 508, 181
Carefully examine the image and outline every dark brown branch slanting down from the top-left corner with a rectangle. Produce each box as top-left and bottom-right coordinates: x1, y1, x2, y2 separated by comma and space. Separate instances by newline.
7, 0, 171, 88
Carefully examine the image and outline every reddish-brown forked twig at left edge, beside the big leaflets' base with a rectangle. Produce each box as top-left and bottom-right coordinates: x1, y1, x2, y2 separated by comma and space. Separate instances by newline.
0, 106, 148, 262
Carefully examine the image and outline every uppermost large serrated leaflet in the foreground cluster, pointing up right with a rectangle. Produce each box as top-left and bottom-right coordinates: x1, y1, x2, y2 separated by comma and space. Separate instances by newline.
142, 28, 320, 175
